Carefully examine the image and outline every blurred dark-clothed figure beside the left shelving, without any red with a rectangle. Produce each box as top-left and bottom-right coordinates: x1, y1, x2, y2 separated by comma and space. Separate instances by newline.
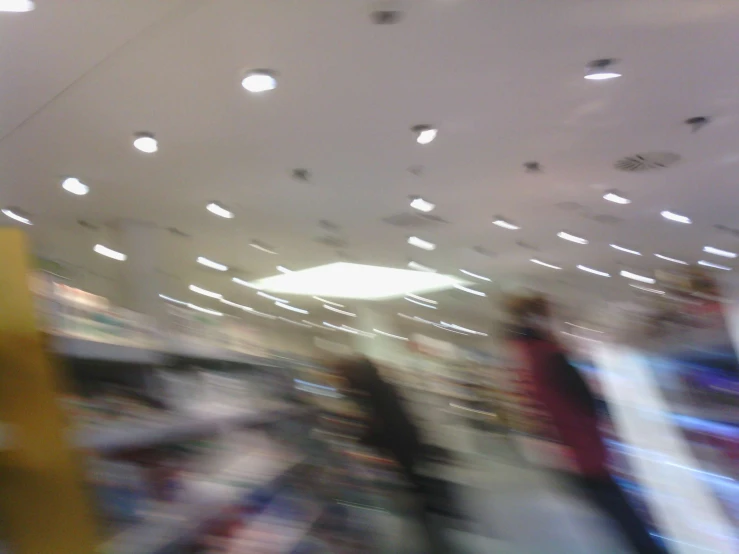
336, 358, 454, 554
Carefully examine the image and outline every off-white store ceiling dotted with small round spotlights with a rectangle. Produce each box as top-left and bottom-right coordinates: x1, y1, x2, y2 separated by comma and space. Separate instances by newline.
0, 0, 739, 332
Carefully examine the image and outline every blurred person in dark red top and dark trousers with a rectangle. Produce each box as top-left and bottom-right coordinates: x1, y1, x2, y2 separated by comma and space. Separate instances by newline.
507, 296, 665, 554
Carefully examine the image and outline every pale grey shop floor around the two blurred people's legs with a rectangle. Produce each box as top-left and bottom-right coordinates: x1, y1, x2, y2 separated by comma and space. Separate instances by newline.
371, 386, 630, 554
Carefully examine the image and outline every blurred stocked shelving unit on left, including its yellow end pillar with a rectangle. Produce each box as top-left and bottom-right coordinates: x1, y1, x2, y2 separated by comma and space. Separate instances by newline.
0, 229, 378, 554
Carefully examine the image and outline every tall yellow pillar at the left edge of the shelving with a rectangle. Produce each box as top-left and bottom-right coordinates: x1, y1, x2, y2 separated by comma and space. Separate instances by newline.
0, 228, 98, 554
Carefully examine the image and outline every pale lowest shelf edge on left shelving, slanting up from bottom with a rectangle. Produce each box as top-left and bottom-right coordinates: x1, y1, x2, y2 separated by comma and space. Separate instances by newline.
100, 451, 304, 554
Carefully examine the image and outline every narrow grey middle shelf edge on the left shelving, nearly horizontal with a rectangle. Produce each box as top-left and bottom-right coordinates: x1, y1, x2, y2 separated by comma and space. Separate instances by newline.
75, 406, 301, 453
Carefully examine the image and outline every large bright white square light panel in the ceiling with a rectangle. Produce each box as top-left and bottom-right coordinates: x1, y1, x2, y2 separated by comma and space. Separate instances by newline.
254, 262, 467, 300
